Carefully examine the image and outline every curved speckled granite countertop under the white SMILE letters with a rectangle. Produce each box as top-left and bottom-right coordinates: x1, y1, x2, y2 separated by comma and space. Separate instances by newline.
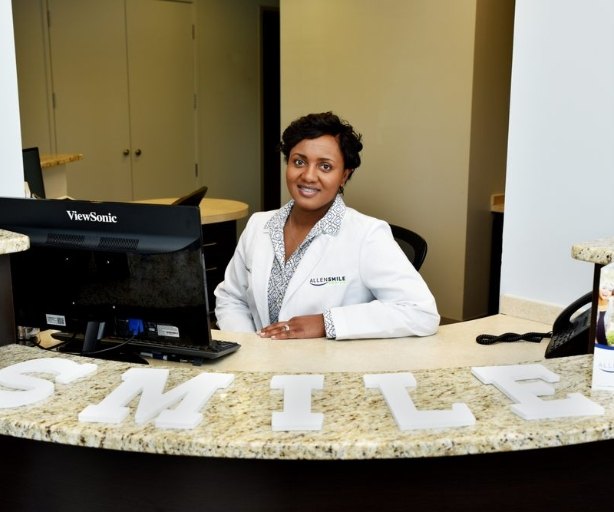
0, 345, 614, 459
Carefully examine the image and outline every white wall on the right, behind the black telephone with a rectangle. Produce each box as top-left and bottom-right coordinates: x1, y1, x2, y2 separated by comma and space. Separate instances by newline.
501, 0, 614, 322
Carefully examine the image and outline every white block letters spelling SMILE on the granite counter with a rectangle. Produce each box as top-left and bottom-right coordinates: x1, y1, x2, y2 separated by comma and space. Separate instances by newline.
0, 358, 604, 431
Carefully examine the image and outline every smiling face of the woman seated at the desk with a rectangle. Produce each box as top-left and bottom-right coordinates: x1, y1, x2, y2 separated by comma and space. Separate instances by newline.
286, 135, 350, 216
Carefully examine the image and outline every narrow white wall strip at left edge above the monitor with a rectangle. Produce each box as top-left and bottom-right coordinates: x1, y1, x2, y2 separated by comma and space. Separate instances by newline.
0, 0, 24, 197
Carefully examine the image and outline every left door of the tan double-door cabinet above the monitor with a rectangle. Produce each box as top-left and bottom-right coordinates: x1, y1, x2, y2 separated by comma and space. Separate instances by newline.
48, 0, 132, 200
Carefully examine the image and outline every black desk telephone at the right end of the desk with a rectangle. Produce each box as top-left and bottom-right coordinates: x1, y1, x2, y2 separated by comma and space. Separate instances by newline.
545, 292, 593, 359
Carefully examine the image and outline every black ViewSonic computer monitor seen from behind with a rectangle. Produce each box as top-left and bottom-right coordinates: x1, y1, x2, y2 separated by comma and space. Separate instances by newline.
0, 194, 231, 359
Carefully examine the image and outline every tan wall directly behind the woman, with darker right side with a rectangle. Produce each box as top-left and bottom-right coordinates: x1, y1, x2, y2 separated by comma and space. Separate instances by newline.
280, 0, 513, 320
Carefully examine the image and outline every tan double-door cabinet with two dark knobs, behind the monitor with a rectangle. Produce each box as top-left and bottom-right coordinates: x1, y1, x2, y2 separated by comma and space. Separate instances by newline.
48, 0, 199, 201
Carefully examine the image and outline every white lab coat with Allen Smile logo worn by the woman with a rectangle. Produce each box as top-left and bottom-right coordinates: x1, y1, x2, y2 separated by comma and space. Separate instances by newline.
215, 204, 439, 340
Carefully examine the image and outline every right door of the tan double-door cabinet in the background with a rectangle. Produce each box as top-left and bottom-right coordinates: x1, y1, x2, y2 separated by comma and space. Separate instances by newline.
126, 0, 198, 199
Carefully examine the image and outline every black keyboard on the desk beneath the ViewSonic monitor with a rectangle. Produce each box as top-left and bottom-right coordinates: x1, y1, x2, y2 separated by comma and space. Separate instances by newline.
51, 332, 241, 363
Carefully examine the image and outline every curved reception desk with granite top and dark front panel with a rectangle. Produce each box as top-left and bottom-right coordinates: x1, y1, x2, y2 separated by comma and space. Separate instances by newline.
0, 315, 614, 511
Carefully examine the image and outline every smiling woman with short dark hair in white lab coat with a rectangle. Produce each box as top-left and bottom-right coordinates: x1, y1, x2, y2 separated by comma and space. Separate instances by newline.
215, 112, 439, 340
